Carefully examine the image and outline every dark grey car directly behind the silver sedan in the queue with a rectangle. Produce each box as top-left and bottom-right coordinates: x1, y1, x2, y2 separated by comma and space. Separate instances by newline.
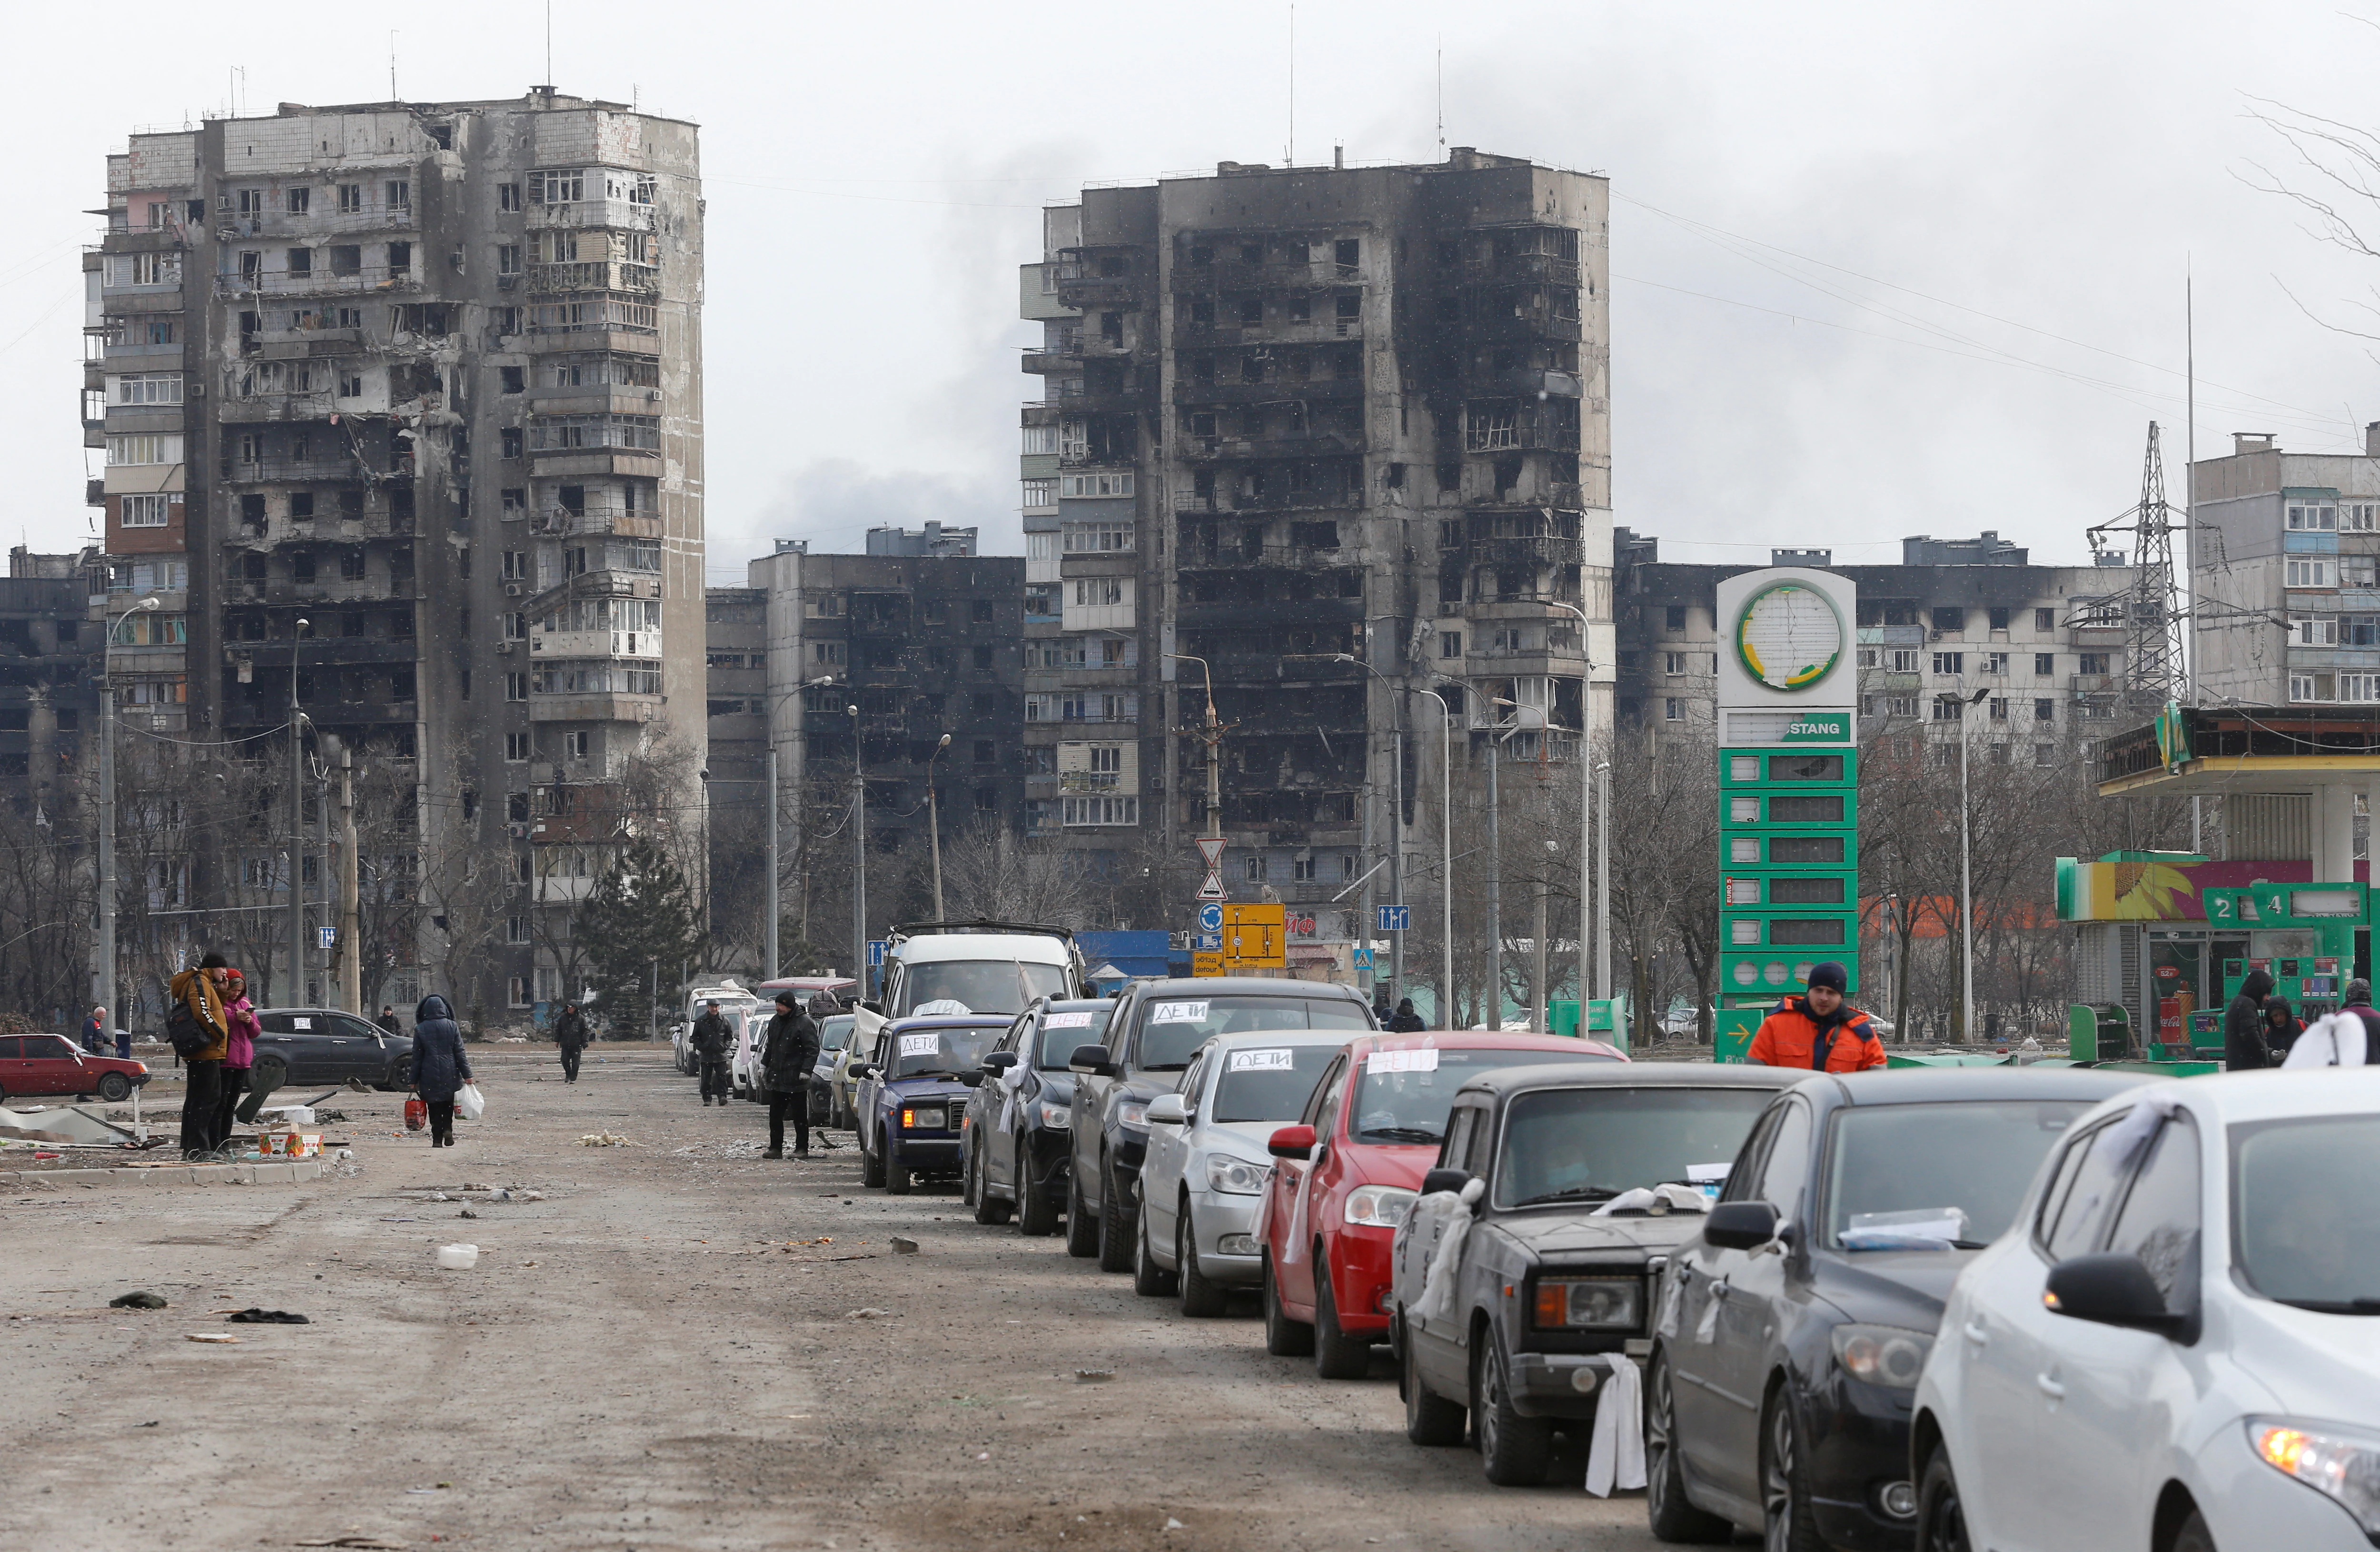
1066, 976, 1380, 1271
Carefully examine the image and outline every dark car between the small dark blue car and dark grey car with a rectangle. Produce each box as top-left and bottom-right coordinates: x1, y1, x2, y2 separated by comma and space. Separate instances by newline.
959, 997, 1116, 1235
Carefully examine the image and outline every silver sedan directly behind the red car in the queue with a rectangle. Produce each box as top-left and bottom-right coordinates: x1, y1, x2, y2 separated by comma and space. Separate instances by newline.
1133, 1028, 1361, 1316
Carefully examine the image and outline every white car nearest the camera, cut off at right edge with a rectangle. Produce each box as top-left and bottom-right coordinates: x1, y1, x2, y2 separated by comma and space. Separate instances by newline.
1911, 1066, 2380, 1552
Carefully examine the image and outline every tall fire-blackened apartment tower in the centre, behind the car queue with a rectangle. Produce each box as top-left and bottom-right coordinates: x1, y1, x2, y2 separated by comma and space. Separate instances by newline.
1021, 148, 1611, 957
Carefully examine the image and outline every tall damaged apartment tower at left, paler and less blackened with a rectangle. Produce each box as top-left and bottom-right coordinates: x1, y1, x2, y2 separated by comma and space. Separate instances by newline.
86, 86, 704, 1019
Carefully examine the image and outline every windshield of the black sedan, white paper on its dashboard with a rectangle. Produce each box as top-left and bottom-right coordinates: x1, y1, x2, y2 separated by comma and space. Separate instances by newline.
1825, 1100, 2090, 1250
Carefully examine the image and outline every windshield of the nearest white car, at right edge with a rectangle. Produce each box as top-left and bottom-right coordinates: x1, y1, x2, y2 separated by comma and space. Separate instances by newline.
2232, 1116, 2380, 1314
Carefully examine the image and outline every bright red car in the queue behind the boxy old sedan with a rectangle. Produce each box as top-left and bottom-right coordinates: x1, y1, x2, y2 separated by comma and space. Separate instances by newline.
1257, 1028, 1628, 1381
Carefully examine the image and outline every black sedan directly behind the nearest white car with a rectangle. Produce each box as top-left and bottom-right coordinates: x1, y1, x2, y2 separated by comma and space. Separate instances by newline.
1645, 1066, 2142, 1550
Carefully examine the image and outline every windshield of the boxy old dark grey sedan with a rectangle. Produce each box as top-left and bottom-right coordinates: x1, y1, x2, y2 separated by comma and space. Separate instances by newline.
1495, 1085, 1775, 1207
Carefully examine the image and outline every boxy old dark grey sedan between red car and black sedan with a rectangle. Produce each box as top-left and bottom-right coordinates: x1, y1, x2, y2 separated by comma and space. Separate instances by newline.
1390, 1062, 1809, 1485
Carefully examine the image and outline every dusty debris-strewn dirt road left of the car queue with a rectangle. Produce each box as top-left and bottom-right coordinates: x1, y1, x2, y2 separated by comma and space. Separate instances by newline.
0, 1047, 1654, 1552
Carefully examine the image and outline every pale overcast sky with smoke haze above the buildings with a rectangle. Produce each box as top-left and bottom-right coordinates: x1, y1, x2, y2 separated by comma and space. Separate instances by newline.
14, 0, 2380, 583
